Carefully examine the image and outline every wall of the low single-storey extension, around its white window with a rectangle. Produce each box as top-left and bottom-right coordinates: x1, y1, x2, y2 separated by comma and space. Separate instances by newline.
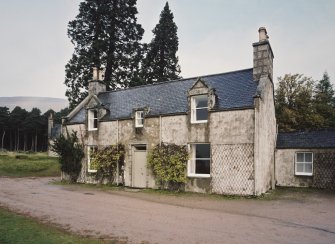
275, 149, 335, 189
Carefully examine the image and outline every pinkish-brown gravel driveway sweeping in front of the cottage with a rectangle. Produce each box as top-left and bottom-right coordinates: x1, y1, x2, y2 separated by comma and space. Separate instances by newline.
0, 178, 335, 243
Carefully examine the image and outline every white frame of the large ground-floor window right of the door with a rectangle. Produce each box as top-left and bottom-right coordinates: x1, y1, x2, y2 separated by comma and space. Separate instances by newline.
187, 143, 212, 178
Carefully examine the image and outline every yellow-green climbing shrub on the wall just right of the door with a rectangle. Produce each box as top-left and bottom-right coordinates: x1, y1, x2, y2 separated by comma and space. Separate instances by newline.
148, 143, 189, 189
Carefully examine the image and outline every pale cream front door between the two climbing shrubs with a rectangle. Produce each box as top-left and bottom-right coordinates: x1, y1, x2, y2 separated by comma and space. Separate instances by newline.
132, 145, 147, 188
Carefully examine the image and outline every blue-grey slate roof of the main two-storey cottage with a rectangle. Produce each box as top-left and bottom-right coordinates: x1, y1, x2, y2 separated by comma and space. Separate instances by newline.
69, 69, 257, 123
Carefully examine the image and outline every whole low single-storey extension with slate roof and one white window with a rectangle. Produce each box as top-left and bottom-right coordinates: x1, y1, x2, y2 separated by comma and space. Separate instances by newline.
275, 129, 335, 189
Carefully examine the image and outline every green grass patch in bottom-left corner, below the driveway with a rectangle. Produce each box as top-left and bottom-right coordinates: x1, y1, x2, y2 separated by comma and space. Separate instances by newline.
0, 208, 115, 244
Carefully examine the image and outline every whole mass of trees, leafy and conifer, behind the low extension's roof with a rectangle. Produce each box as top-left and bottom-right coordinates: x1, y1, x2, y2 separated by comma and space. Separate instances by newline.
275, 74, 335, 131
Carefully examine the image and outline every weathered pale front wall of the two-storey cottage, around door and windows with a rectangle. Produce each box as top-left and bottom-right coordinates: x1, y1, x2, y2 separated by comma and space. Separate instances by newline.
64, 109, 260, 194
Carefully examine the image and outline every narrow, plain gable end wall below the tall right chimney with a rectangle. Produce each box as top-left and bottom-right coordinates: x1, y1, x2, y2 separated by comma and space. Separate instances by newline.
254, 75, 276, 195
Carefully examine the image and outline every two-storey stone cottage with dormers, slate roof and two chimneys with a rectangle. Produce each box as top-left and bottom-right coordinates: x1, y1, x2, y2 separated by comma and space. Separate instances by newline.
63, 28, 276, 195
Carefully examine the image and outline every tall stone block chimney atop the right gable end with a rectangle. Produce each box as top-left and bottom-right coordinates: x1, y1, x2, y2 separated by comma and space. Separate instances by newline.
252, 27, 274, 81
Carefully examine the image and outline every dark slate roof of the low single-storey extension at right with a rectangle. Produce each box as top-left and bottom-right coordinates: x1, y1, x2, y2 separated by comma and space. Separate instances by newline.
277, 128, 335, 149
